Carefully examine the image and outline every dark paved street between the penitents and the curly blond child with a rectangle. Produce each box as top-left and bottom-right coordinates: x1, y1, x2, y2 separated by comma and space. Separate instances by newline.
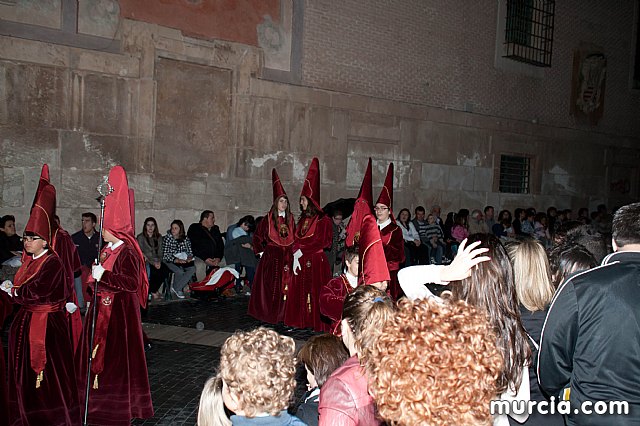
2, 296, 313, 426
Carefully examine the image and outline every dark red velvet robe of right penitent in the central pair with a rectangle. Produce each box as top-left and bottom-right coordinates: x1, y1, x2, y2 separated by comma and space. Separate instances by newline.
284, 215, 333, 332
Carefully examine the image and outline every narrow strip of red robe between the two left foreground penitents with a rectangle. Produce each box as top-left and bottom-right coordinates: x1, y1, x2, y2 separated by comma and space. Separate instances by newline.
51, 228, 82, 353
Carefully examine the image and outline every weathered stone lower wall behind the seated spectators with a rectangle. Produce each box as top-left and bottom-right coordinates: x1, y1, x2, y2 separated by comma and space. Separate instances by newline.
0, 0, 640, 236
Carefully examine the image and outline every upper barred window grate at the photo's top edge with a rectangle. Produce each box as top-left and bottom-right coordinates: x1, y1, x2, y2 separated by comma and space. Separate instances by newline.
503, 0, 555, 67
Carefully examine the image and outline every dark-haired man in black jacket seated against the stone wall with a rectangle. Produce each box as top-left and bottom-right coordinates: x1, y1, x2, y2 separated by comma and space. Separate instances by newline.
187, 210, 224, 281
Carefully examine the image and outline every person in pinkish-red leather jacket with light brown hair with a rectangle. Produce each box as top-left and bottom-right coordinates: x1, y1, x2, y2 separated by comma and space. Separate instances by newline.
318, 285, 394, 426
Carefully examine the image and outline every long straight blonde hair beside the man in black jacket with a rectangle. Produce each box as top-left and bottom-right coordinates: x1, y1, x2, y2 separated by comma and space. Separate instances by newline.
507, 240, 554, 312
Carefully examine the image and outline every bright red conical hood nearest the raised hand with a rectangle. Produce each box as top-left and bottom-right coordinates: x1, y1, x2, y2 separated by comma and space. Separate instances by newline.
358, 214, 391, 284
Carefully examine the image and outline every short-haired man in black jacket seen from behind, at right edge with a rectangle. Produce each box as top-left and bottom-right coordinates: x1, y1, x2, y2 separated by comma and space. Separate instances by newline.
538, 203, 640, 426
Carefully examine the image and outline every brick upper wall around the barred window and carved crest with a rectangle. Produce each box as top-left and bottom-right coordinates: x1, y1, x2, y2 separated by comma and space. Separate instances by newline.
302, 0, 640, 135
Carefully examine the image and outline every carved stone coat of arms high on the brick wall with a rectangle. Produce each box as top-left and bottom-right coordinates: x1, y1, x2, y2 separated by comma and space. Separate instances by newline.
571, 49, 607, 125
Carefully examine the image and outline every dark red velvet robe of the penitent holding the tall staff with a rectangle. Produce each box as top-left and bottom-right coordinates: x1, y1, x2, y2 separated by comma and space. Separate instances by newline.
76, 242, 153, 425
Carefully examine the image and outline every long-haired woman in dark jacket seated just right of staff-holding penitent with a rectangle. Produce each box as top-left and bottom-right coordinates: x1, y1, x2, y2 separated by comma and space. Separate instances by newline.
136, 217, 170, 300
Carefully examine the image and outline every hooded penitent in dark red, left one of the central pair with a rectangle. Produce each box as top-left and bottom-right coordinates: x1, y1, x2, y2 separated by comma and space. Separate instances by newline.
248, 169, 295, 324
